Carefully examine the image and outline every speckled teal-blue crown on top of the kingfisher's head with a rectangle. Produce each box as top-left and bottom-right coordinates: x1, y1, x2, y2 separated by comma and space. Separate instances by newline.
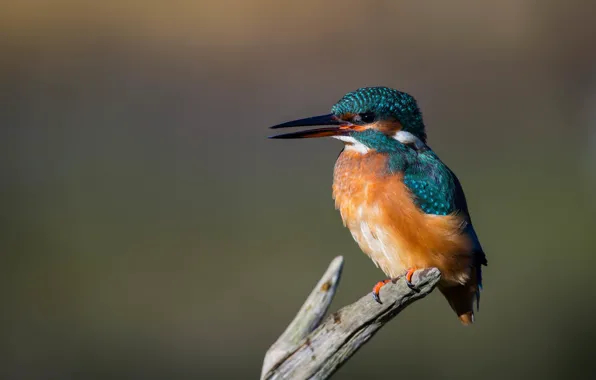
331, 87, 426, 142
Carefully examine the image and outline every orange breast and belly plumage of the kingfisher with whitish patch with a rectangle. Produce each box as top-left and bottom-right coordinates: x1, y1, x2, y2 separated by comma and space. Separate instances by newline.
333, 150, 472, 284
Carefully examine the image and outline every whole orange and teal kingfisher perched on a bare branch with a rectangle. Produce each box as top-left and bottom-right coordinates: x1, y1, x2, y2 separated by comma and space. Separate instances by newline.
270, 87, 487, 325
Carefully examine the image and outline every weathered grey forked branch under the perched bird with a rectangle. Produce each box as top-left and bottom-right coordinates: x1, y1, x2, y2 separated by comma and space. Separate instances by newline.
261, 256, 441, 380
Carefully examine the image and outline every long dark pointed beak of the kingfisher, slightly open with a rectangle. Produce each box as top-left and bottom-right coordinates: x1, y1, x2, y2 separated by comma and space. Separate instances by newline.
269, 113, 354, 139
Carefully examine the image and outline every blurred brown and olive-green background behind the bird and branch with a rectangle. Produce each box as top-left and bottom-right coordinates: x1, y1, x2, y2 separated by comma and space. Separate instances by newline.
0, 0, 596, 380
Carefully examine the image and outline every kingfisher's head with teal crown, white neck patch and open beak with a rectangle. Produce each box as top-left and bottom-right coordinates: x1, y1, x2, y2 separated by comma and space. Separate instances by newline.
271, 87, 426, 150
